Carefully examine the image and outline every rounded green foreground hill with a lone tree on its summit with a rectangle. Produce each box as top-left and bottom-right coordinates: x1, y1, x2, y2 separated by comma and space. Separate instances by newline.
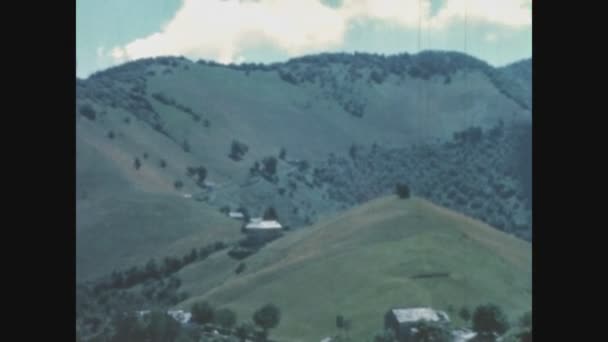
173, 196, 532, 341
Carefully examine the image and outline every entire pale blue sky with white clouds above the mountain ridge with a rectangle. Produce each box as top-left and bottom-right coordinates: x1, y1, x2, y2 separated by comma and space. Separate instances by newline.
76, 0, 532, 78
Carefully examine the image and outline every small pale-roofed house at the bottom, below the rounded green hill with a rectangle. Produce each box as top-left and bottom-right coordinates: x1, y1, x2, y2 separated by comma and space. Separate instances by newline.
384, 308, 450, 342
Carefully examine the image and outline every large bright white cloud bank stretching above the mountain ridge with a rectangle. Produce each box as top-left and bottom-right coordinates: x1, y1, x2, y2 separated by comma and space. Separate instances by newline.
108, 0, 531, 63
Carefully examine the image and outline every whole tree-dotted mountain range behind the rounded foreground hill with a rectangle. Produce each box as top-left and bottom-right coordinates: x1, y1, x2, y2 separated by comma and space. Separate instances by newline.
76, 51, 532, 279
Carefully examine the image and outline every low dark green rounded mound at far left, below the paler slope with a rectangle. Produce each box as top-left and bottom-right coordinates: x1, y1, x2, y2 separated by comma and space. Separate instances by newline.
76, 193, 240, 280
